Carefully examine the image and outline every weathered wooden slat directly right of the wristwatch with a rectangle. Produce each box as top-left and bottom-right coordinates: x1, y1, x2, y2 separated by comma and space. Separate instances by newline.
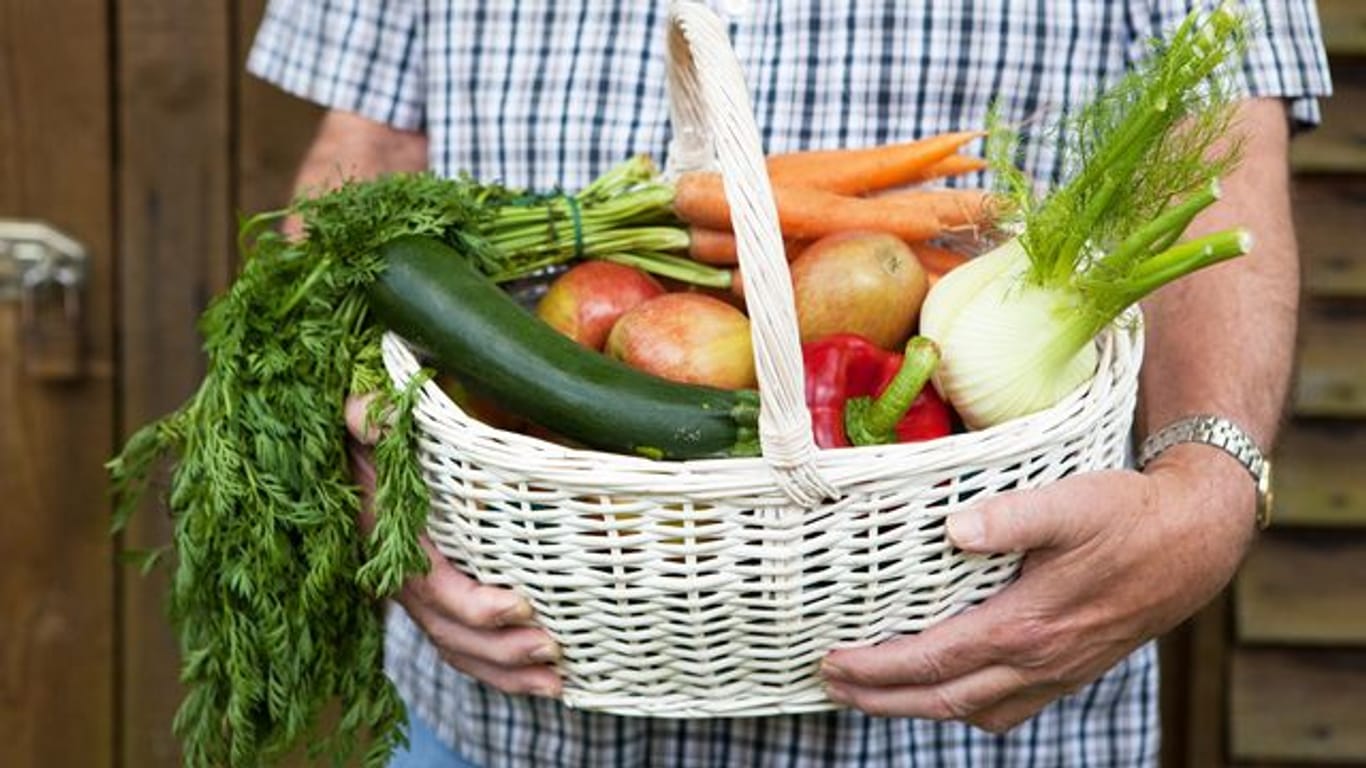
1273, 418, 1366, 522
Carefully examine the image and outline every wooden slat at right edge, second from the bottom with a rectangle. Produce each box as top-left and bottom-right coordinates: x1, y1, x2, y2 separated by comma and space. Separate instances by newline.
1233, 530, 1366, 648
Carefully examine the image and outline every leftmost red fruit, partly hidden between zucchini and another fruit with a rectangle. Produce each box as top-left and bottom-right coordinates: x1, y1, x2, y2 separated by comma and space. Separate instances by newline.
535, 261, 664, 350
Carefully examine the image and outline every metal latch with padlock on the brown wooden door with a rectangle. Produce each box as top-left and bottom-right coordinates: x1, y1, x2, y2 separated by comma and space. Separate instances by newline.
0, 219, 89, 380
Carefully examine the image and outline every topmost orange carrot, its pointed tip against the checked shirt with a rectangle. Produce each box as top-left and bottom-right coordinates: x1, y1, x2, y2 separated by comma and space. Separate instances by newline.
768, 131, 982, 194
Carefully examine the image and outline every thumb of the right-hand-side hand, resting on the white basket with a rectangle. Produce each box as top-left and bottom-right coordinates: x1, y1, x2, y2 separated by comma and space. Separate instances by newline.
948, 473, 1119, 553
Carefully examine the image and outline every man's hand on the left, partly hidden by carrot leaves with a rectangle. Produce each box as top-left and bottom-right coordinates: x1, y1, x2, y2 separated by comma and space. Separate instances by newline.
346, 390, 560, 697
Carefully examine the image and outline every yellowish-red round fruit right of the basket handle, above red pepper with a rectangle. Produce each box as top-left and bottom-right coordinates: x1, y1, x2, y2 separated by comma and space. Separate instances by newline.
791, 231, 929, 350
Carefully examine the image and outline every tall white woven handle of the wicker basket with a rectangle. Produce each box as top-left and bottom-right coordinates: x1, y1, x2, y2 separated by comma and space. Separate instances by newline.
668, 0, 837, 507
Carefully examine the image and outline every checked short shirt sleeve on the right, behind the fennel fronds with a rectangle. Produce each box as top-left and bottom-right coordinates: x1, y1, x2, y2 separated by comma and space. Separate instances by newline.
1131, 0, 1333, 128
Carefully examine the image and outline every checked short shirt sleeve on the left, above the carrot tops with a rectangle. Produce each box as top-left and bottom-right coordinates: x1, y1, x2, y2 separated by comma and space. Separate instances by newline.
247, 0, 425, 130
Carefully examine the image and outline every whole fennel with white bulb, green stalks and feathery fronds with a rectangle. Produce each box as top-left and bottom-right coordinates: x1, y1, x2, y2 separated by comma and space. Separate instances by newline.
921, 5, 1251, 429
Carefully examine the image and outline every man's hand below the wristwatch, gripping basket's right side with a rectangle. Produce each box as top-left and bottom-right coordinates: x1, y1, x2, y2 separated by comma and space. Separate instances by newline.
822, 445, 1254, 732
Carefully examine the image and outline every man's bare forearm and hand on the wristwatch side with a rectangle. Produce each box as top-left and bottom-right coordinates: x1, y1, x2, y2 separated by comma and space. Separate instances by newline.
825, 98, 1299, 731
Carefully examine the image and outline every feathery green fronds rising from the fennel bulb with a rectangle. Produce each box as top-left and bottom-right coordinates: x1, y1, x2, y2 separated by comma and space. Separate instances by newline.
988, 5, 1244, 311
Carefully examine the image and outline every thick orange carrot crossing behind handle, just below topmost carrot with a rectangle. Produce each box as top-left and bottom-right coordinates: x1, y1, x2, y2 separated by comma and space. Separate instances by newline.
673, 171, 951, 241
